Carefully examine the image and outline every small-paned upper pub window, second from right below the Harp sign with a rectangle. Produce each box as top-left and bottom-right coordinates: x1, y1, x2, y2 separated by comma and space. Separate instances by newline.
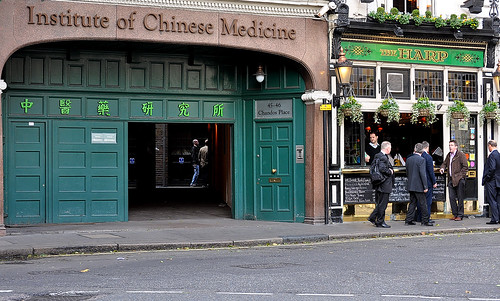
415, 70, 443, 100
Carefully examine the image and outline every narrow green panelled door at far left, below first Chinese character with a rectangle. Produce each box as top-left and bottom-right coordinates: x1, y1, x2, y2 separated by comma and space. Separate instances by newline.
5, 121, 46, 224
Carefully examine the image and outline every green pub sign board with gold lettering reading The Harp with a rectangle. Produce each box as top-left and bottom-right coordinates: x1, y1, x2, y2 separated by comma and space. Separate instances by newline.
342, 41, 485, 67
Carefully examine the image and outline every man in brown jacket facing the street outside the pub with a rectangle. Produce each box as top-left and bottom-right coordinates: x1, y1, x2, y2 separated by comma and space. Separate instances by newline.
439, 140, 469, 221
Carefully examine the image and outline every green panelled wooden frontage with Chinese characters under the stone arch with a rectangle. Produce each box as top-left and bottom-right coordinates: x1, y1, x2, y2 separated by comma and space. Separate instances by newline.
2, 49, 305, 224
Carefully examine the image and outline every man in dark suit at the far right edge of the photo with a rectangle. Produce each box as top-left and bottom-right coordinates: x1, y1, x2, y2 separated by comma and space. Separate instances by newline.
482, 140, 500, 225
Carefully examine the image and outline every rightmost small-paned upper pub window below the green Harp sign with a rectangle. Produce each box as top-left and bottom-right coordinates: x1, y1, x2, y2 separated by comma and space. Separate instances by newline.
448, 72, 478, 102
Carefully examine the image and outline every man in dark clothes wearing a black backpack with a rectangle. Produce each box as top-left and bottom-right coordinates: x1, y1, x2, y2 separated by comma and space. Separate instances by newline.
368, 141, 394, 228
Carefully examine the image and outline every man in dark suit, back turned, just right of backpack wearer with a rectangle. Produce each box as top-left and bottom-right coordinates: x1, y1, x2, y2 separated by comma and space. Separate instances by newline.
405, 143, 433, 226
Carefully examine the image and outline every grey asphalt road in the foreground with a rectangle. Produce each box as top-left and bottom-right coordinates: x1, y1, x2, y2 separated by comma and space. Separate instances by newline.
0, 233, 500, 301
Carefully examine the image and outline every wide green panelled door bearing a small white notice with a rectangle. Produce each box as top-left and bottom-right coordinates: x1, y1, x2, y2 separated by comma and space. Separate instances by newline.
51, 120, 128, 223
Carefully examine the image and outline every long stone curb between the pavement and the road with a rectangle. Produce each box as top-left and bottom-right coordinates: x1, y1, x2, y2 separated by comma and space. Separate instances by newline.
0, 226, 500, 261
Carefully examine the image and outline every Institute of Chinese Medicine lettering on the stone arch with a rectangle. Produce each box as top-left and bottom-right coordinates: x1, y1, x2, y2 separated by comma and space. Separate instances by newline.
27, 5, 297, 40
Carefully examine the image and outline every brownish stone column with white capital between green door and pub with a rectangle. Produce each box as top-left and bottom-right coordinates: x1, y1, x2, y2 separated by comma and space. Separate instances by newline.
302, 91, 331, 224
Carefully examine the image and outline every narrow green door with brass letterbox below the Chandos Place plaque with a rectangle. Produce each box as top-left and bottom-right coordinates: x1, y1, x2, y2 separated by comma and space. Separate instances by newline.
255, 122, 295, 222
